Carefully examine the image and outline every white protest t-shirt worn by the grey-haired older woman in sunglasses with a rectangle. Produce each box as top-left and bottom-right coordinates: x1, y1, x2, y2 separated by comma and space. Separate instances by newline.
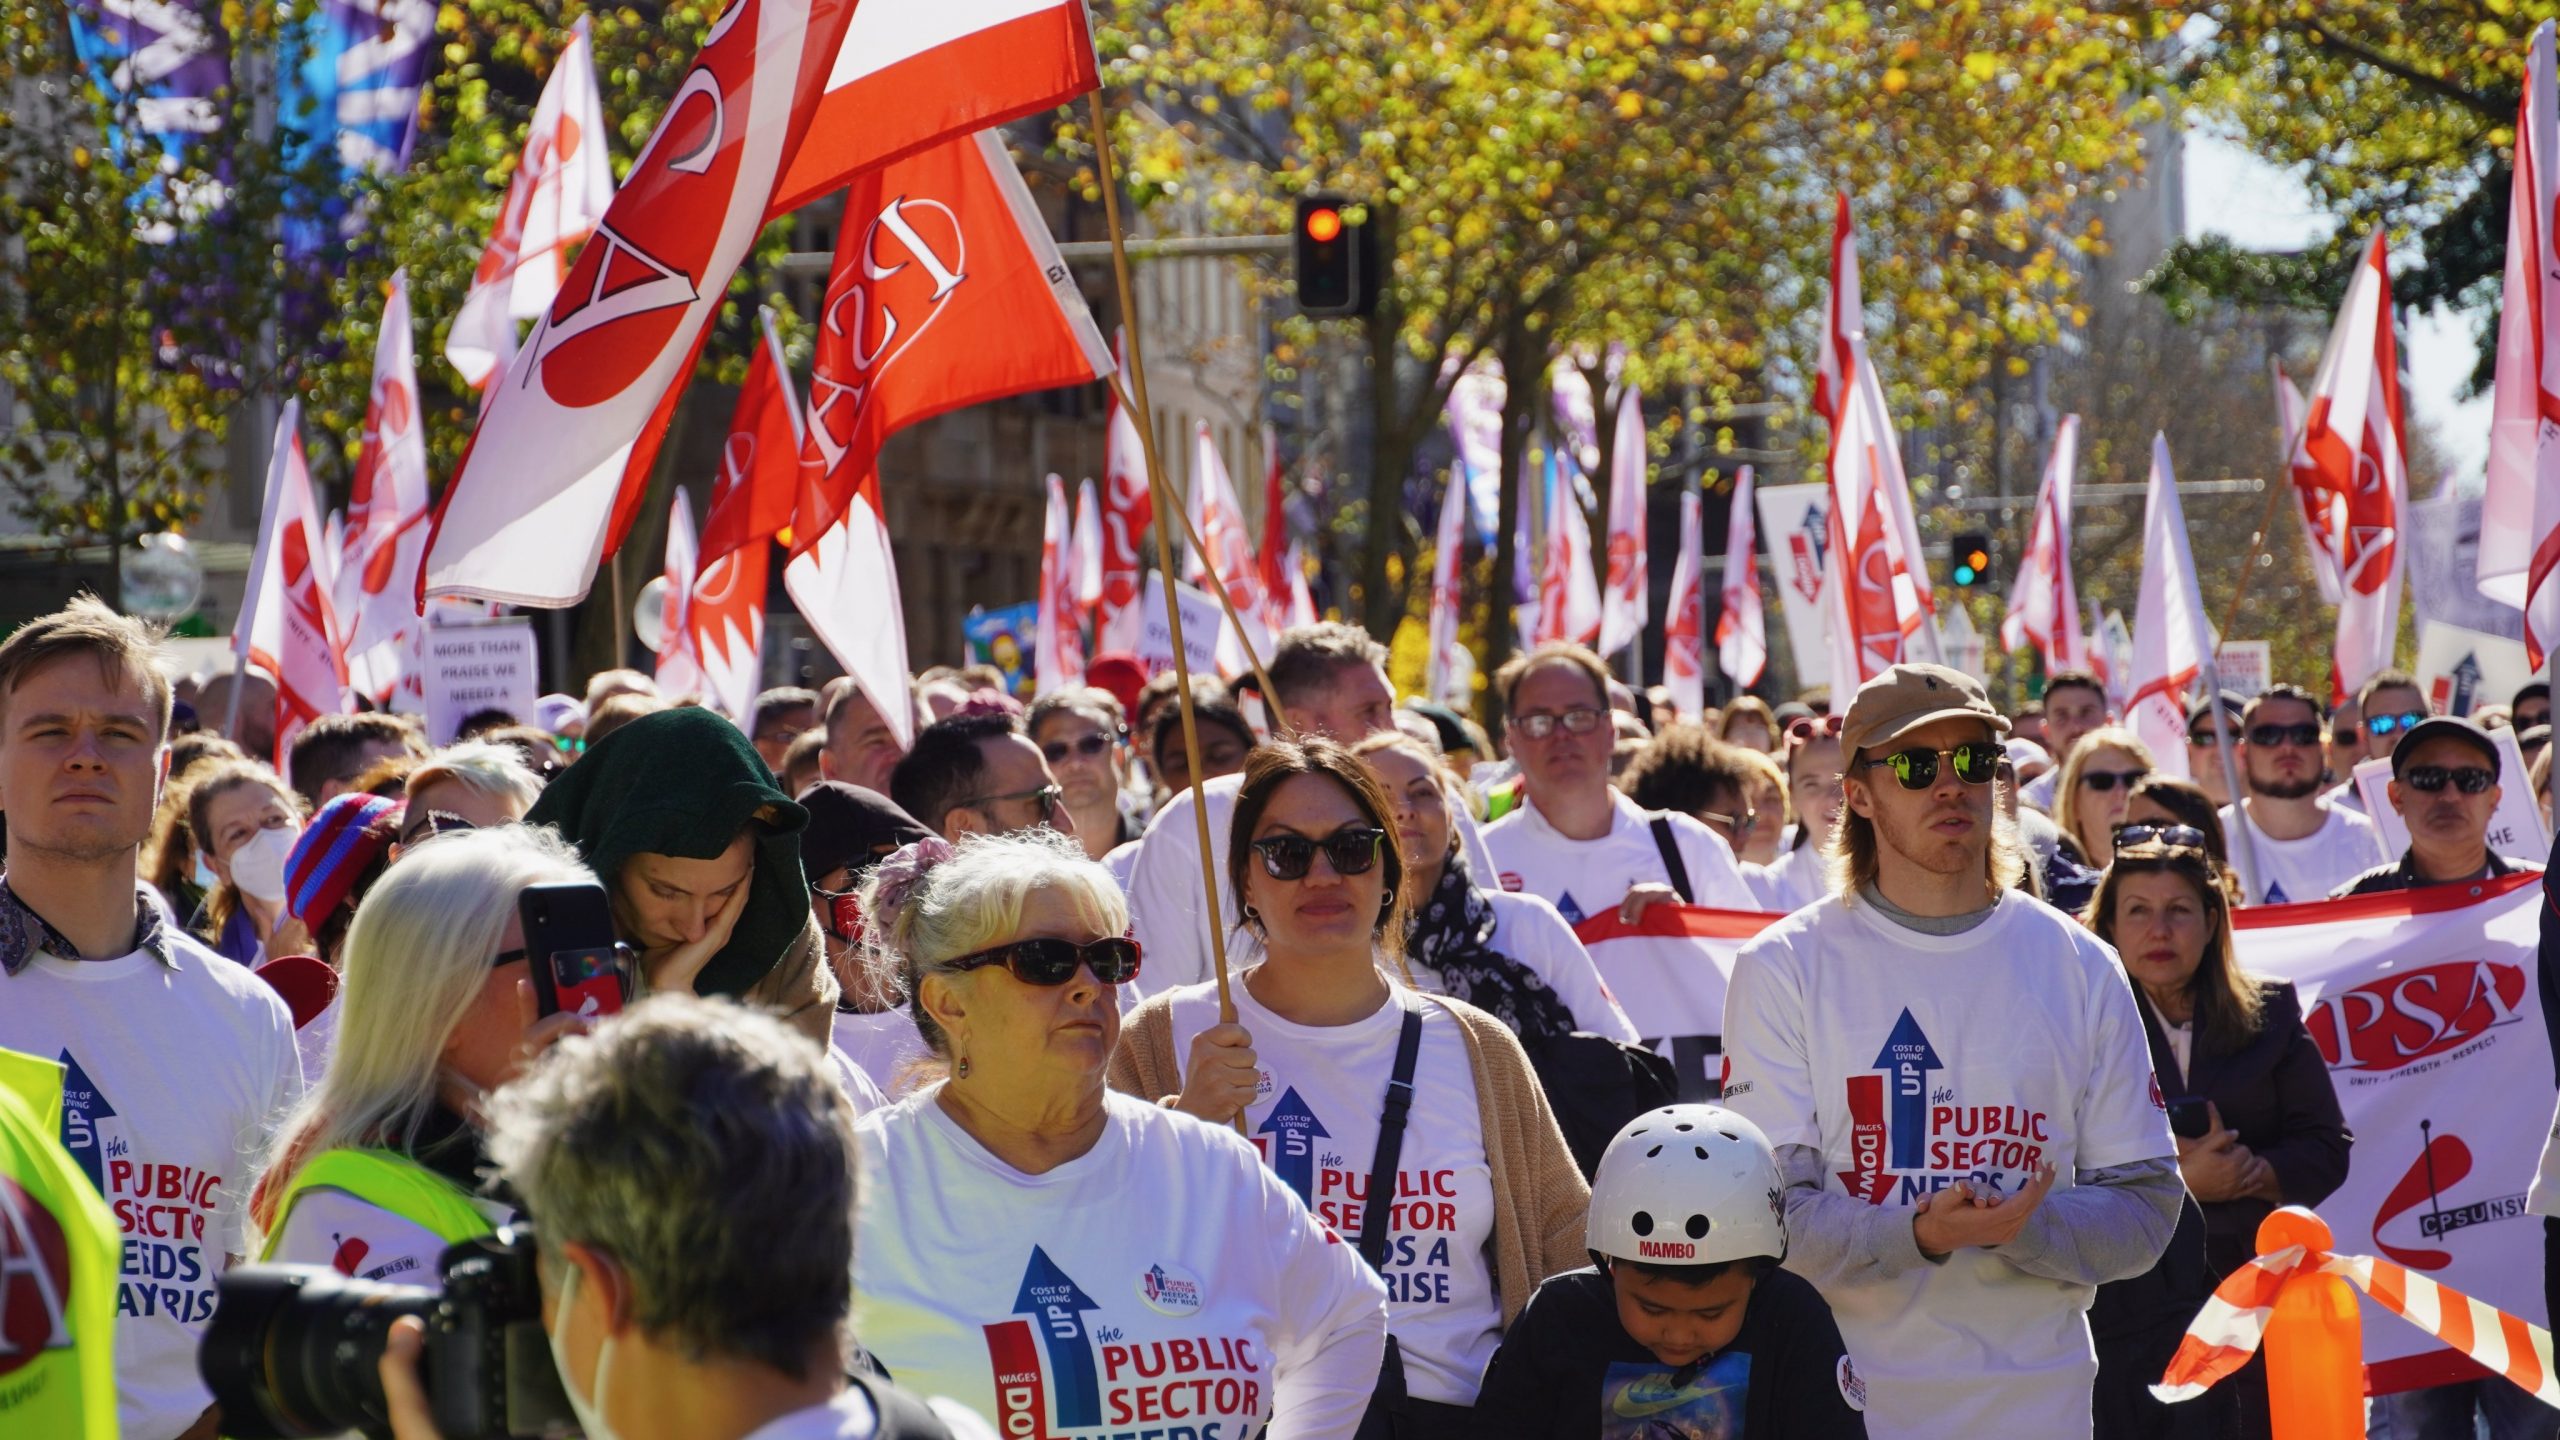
852, 1086, 1388, 1440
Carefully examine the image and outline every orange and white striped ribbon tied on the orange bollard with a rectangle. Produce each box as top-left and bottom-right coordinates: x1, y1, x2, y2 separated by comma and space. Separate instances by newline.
2150, 1245, 2560, 1409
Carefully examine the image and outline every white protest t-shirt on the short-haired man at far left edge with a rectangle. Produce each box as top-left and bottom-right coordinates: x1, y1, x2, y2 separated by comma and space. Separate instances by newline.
0, 928, 302, 1440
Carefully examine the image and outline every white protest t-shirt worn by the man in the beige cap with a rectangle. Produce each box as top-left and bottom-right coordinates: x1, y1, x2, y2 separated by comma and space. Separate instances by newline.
1723, 889, 2176, 1440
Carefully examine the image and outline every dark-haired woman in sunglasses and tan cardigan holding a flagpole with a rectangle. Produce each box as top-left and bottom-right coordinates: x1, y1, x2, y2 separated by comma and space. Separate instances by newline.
1111, 740, 1590, 1437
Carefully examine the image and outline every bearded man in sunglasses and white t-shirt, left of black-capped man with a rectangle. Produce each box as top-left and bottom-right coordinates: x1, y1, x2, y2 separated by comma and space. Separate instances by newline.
2222, 684, 2388, 904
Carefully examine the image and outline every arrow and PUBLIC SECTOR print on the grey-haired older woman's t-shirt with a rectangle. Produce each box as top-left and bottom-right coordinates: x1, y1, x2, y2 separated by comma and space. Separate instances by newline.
980, 1245, 1267, 1440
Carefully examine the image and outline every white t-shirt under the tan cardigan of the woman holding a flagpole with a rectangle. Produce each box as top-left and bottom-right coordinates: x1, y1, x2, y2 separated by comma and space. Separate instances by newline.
1172, 976, 1503, 1404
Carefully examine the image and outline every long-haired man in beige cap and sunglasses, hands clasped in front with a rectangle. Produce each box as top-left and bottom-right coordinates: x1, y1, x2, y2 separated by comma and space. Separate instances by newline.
1723, 666, 2184, 1440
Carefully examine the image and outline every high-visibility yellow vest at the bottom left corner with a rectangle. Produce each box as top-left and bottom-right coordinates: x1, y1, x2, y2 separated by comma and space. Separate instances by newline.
0, 1051, 123, 1440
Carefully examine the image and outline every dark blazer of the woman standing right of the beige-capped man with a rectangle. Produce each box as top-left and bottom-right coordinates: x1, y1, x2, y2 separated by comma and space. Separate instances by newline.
2132, 981, 2355, 1276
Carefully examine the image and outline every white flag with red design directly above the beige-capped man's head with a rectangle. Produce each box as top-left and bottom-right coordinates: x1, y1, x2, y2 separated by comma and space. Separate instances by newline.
1823, 336, 1938, 694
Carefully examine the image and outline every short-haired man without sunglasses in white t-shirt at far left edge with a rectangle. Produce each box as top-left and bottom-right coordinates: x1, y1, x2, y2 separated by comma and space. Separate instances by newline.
0, 597, 302, 1440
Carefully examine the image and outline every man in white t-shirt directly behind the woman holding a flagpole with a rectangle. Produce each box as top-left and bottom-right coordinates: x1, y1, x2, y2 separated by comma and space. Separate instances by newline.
1124, 620, 1490, 1002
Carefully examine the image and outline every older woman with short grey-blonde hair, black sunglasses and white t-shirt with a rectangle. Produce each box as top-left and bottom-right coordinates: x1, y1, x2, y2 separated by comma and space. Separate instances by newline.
852, 830, 1385, 1440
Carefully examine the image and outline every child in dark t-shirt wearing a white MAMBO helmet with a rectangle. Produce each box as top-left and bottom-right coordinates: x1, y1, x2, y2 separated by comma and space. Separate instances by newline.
1475, 1104, 1866, 1440
